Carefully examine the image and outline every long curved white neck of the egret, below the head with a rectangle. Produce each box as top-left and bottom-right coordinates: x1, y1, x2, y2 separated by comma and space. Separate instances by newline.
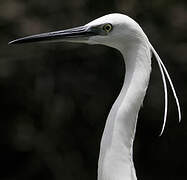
98, 41, 151, 180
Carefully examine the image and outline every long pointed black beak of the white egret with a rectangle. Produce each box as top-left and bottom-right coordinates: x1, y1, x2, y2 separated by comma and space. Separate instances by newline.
8, 26, 97, 44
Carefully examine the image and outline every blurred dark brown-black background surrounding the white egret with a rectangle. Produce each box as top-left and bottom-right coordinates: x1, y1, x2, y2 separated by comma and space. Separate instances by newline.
0, 0, 187, 180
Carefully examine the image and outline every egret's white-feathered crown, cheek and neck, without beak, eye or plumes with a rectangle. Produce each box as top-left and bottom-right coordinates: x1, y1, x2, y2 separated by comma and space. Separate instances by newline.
88, 14, 151, 180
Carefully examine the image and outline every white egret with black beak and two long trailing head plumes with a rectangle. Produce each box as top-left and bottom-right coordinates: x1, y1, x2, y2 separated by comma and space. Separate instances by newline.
9, 13, 181, 180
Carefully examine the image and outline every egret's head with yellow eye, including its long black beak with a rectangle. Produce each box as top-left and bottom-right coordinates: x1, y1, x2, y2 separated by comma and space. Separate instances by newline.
9, 13, 146, 49
